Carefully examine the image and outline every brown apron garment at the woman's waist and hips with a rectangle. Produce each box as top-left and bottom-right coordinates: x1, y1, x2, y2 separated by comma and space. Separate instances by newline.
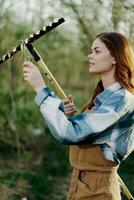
67, 145, 121, 200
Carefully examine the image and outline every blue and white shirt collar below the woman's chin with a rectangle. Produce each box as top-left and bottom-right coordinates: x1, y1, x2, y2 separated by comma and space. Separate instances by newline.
94, 82, 122, 104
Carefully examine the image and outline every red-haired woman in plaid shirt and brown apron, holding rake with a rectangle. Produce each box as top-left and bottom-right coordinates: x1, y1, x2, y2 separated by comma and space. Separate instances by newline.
23, 32, 134, 200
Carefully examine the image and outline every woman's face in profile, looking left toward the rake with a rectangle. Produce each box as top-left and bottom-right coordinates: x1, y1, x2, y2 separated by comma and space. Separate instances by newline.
88, 38, 115, 74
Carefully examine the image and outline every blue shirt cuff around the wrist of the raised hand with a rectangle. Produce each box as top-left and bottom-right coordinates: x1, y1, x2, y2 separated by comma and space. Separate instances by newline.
35, 87, 55, 106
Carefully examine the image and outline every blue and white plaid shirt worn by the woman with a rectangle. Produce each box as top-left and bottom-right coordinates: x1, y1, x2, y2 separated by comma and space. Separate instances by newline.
35, 82, 134, 164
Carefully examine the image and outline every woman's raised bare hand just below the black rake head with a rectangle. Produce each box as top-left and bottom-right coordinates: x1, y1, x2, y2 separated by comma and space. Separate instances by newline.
23, 61, 47, 92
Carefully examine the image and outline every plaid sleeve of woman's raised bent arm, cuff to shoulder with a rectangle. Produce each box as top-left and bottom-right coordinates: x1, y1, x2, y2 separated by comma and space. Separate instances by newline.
35, 88, 126, 144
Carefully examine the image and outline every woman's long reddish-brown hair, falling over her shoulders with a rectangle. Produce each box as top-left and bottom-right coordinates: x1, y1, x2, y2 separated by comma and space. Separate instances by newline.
81, 32, 134, 112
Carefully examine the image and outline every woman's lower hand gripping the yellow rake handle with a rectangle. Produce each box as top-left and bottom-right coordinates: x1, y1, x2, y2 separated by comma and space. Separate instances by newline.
64, 95, 77, 117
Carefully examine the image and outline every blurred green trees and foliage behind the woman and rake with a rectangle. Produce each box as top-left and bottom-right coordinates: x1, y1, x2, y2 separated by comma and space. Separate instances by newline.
0, 0, 134, 200
